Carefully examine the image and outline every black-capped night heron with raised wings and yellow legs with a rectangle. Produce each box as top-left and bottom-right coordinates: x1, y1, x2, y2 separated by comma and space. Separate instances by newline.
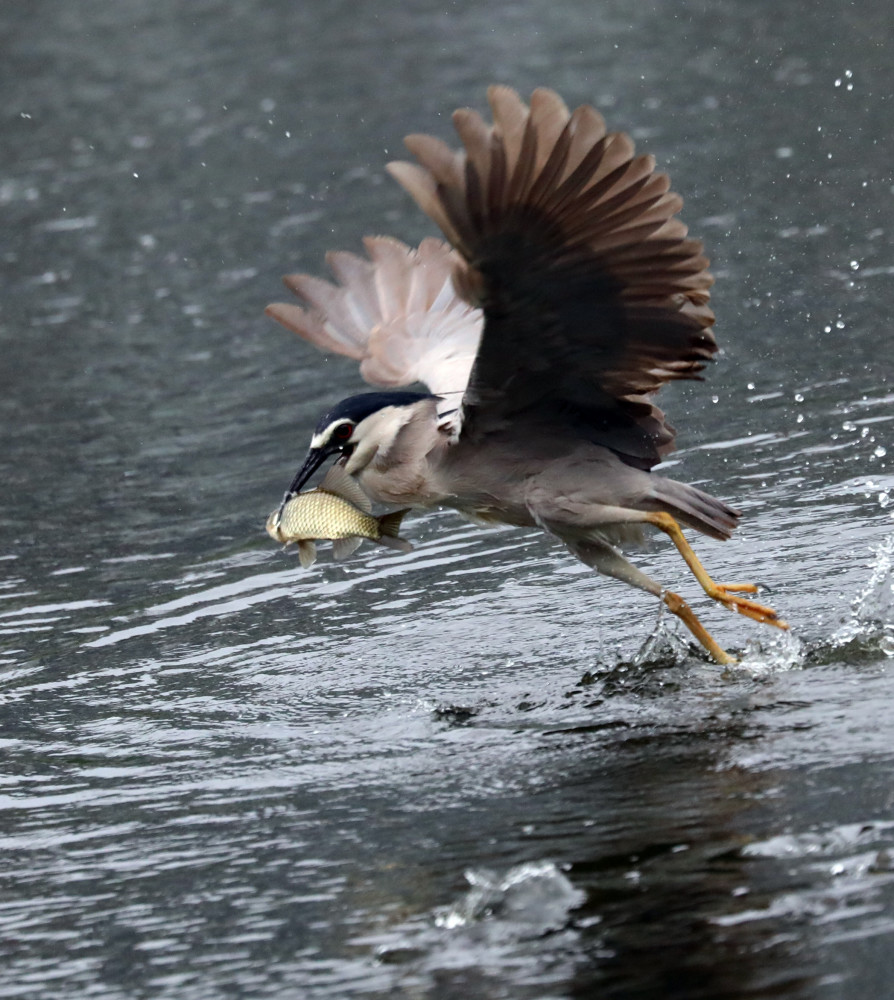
266, 85, 788, 664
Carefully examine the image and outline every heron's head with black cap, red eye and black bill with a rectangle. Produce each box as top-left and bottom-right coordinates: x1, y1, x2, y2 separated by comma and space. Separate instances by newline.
283, 391, 438, 503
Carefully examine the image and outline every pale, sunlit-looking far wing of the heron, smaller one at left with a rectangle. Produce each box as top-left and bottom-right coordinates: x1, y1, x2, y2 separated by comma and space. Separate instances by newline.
266, 236, 483, 407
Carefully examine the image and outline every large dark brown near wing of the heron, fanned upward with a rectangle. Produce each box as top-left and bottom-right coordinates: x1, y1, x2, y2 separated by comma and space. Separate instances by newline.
388, 87, 717, 468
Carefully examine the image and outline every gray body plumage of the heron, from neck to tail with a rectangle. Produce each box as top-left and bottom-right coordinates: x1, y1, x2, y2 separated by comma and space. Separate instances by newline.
346, 400, 738, 541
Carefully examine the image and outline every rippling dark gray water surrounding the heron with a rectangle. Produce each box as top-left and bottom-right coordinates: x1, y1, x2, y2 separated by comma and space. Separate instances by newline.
0, 0, 894, 1000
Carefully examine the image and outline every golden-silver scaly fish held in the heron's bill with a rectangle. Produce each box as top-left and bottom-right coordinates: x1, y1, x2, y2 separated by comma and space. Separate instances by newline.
267, 465, 413, 568
